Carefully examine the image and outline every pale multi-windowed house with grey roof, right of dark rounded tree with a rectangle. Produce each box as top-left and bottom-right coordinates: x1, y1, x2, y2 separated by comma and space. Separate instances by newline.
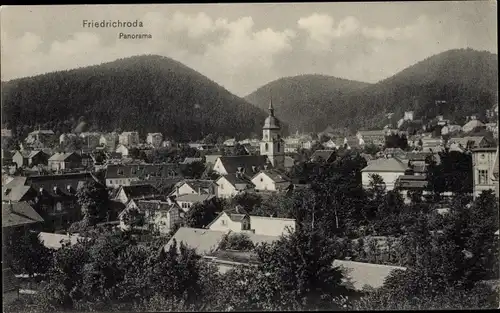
118, 200, 184, 235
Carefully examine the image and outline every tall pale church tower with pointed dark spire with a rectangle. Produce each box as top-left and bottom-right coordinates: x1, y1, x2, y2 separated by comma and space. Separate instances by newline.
260, 97, 285, 169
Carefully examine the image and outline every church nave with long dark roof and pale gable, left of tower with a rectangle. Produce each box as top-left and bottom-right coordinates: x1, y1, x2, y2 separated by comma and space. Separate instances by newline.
213, 155, 272, 175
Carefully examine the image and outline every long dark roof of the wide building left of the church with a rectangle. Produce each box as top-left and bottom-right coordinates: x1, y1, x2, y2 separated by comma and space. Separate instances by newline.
106, 163, 180, 179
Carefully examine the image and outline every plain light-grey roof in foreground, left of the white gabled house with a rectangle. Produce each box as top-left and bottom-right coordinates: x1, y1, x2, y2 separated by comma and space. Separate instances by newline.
163, 227, 228, 255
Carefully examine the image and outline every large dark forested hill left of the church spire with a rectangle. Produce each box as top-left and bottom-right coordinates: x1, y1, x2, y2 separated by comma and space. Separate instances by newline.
2, 55, 274, 140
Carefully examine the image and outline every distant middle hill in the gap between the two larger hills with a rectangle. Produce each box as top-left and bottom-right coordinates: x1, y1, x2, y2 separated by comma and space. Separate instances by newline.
245, 75, 369, 132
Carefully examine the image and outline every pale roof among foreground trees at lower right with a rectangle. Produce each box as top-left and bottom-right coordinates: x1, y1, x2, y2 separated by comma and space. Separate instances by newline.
333, 260, 406, 290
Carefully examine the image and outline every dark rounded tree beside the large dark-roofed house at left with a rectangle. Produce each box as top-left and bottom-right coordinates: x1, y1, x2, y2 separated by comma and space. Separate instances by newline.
76, 181, 110, 225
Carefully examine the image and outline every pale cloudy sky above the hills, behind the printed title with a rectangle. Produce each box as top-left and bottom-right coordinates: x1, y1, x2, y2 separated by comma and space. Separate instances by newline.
0, 1, 497, 96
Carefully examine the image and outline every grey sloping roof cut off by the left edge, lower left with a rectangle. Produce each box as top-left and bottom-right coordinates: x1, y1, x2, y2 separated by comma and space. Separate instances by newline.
2, 202, 43, 228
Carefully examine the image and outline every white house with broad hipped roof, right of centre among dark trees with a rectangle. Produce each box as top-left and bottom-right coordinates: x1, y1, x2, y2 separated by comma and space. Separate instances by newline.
361, 158, 408, 191
